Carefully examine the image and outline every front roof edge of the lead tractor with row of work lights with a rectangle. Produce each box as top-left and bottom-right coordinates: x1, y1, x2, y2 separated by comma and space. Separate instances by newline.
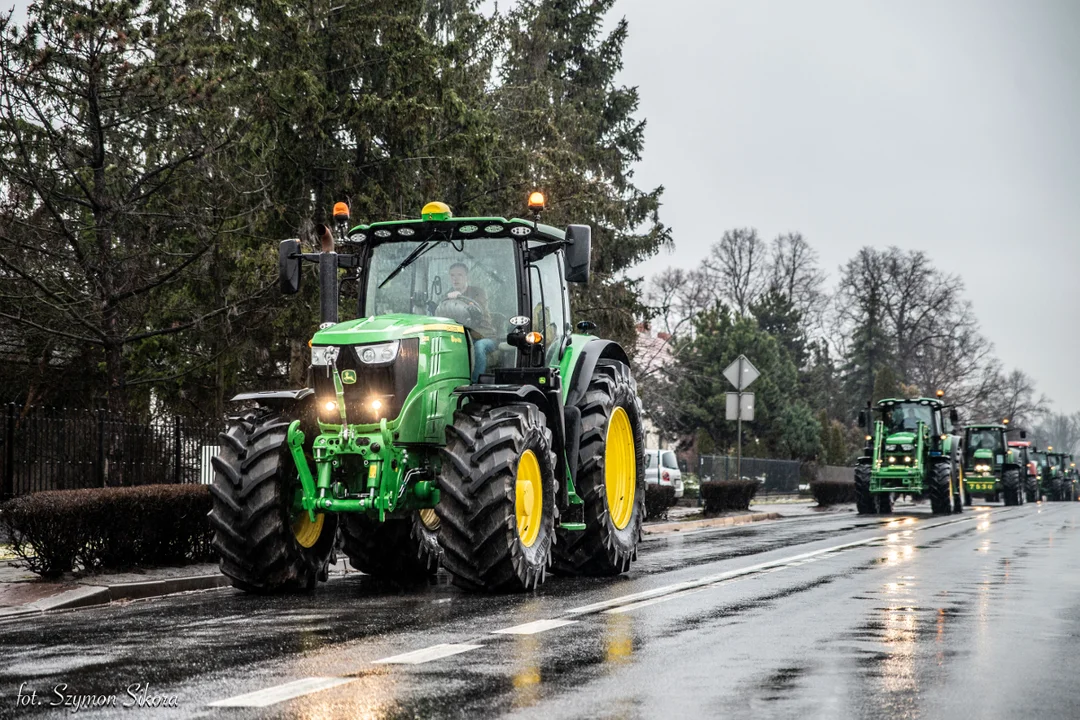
349, 217, 566, 243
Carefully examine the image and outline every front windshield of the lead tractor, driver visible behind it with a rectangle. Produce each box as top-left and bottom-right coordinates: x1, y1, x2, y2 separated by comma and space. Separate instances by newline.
363, 237, 517, 339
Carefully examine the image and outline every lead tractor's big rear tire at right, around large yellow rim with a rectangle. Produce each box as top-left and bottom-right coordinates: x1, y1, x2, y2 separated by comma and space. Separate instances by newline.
554, 359, 645, 575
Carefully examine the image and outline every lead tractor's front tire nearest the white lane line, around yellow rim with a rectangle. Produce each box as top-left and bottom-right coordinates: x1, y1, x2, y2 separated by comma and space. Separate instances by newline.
435, 403, 555, 592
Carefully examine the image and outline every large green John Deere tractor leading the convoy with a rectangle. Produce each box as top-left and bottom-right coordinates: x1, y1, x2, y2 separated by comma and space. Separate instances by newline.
210, 193, 645, 593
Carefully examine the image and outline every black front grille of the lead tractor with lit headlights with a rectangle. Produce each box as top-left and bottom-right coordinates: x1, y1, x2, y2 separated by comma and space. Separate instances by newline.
312, 338, 420, 425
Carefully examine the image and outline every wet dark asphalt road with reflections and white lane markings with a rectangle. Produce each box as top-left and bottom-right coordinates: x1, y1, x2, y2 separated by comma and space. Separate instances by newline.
0, 503, 1080, 720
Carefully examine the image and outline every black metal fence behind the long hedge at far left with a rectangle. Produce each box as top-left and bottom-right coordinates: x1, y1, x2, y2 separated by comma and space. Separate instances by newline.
0, 405, 220, 498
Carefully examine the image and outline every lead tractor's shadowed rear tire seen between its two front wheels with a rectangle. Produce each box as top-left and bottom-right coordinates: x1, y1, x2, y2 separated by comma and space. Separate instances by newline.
341, 511, 442, 585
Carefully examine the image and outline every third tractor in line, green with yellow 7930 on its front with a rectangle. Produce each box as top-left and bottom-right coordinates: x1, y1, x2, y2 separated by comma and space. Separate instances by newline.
963, 424, 1027, 505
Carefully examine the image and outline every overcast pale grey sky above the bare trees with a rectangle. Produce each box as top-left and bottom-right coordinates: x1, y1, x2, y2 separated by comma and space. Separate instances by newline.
612, 0, 1080, 412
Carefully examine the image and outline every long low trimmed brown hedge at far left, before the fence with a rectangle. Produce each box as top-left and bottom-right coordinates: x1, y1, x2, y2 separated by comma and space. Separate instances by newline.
0, 485, 214, 578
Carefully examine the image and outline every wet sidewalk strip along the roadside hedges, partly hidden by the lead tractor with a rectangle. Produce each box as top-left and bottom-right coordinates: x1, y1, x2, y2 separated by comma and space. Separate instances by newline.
0, 501, 854, 621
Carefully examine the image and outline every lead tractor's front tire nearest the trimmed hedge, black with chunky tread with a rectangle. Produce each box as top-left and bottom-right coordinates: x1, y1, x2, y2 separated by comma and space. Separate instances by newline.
210, 406, 337, 594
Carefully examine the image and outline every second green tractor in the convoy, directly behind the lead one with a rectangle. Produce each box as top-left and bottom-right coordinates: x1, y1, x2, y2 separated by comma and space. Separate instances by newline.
855, 392, 963, 515
